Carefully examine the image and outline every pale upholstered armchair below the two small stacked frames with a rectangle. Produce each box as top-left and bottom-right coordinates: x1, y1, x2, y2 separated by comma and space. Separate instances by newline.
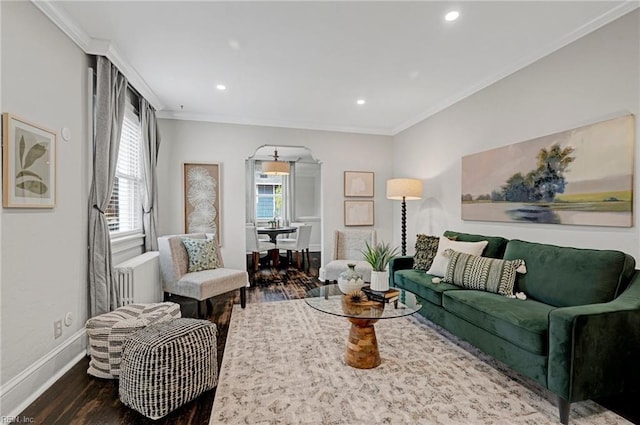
319, 230, 376, 282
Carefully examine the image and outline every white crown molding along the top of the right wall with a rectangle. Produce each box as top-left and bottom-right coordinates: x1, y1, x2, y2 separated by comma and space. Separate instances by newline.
391, 0, 640, 136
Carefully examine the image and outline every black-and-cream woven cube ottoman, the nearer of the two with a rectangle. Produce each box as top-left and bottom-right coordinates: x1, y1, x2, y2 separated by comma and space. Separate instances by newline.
119, 319, 218, 419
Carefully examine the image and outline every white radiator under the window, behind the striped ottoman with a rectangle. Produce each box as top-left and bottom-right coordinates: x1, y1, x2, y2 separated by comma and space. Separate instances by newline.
114, 251, 162, 307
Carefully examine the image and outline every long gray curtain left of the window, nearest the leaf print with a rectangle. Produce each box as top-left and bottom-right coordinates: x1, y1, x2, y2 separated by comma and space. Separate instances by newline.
89, 56, 127, 317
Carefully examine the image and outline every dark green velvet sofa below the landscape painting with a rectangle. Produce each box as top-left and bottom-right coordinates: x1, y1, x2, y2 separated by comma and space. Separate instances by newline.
389, 231, 640, 424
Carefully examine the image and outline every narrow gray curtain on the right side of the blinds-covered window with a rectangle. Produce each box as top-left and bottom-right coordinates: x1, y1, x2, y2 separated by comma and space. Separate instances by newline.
140, 96, 160, 251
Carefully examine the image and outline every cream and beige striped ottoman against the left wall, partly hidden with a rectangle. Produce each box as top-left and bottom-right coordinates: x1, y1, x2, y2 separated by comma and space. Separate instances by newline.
85, 302, 181, 379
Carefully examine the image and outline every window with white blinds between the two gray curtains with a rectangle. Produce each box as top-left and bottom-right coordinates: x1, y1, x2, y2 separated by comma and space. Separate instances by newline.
105, 99, 142, 237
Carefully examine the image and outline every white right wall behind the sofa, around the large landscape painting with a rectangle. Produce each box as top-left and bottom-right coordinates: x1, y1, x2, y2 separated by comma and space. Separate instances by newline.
394, 10, 640, 258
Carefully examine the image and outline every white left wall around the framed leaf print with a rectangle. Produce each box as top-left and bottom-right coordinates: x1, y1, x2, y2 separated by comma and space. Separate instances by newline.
0, 2, 88, 415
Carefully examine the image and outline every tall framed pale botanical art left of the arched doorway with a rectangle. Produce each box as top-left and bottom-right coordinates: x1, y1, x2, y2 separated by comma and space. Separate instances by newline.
182, 163, 222, 244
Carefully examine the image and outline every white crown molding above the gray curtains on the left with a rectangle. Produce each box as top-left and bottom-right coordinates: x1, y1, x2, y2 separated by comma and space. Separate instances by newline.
31, 0, 164, 110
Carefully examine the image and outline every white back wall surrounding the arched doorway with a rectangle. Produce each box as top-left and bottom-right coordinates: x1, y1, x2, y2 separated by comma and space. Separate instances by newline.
158, 120, 399, 269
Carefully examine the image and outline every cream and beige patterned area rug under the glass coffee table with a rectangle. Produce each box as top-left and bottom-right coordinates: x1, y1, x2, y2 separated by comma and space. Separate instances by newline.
210, 300, 630, 425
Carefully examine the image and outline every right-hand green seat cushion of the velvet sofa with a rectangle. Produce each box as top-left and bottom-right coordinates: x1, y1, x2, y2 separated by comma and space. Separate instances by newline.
442, 290, 554, 355
